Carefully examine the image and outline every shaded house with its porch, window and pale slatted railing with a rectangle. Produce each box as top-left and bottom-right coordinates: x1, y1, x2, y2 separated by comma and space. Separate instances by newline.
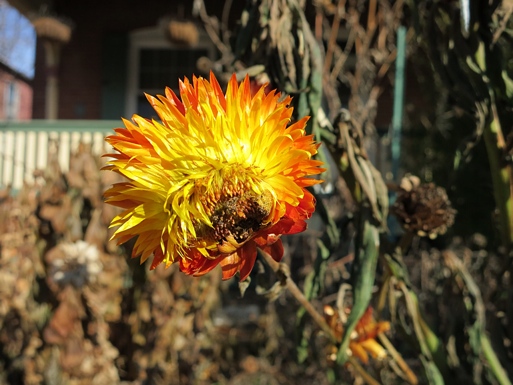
0, 0, 234, 191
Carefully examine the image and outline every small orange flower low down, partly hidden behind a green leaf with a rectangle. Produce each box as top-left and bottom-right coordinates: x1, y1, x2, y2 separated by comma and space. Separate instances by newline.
324, 305, 390, 364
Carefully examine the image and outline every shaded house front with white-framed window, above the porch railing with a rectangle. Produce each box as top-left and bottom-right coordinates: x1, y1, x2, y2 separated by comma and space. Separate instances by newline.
9, 0, 238, 120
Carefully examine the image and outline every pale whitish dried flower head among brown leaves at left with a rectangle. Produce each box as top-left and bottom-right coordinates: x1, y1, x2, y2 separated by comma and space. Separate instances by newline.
48, 241, 103, 288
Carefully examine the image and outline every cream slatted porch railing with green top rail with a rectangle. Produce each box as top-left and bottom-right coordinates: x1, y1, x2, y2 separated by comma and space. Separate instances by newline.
0, 120, 118, 191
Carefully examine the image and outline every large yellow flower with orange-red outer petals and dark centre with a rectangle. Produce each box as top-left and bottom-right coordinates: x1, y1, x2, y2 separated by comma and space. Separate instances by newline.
105, 74, 323, 280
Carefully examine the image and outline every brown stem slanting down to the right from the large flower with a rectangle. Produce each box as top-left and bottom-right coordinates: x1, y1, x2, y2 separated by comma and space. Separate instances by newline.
260, 250, 380, 385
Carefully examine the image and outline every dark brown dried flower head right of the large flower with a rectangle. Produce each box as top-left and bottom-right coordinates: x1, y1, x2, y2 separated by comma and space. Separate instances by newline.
392, 175, 456, 239
